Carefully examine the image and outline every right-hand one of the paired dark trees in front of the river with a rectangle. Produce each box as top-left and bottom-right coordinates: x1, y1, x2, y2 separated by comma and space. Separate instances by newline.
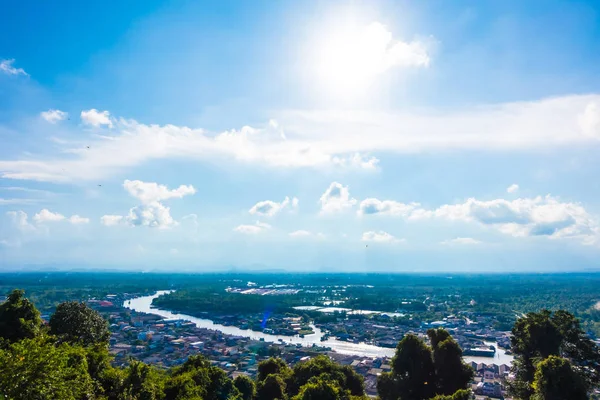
427, 329, 474, 395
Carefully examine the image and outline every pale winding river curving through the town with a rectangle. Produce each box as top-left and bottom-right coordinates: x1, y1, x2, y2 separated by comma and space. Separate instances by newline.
123, 290, 512, 365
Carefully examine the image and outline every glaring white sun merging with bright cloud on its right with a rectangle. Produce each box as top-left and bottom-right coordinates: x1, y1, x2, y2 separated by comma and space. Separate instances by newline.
314, 22, 429, 95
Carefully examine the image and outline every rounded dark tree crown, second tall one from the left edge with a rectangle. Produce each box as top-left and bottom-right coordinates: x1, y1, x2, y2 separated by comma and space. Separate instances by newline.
50, 301, 110, 346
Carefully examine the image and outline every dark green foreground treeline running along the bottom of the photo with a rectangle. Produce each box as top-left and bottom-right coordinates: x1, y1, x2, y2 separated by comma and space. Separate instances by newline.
0, 290, 600, 400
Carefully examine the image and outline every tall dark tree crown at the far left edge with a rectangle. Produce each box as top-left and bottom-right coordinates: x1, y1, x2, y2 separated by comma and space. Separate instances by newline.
0, 289, 42, 343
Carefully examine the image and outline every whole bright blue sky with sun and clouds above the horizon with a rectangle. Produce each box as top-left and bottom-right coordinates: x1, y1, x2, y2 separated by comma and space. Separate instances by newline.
0, 1, 600, 272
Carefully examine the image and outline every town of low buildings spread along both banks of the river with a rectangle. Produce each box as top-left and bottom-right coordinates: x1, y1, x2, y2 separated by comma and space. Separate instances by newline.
88, 294, 510, 398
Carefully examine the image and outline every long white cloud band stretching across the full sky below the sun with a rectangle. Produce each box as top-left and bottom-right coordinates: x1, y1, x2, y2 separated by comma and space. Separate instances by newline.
0, 95, 600, 182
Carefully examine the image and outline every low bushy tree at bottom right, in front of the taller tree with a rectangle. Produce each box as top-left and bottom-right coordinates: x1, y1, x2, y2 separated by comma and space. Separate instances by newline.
532, 356, 588, 400
